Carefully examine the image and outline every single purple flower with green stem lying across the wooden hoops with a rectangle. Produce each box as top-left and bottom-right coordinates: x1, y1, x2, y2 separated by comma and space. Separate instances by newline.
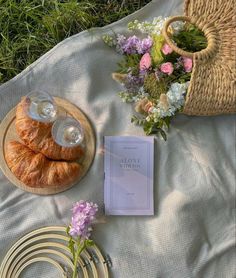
67, 200, 98, 278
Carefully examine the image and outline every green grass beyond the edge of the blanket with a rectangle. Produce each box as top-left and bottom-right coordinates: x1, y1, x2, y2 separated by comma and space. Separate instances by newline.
0, 0, 150, 84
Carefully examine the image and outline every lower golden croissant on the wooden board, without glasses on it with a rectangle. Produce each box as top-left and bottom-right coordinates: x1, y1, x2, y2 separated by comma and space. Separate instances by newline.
5, 141, 81, 187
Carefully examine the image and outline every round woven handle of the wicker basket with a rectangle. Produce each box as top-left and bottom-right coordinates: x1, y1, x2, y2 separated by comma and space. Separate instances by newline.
162, 16, 217, 58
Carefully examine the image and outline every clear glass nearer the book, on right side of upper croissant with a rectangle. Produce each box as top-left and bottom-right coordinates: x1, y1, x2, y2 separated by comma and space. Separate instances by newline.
52, 116, 84, 147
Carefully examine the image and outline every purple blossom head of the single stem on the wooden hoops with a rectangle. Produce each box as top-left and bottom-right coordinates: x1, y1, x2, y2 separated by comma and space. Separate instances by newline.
69, 201, 98, 240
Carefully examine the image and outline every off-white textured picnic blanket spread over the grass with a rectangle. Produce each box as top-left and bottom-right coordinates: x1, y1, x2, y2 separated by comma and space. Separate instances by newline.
0, 0, 236, 278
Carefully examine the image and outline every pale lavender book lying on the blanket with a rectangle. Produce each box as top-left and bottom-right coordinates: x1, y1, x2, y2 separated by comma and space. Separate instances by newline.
104, 136, 154, 215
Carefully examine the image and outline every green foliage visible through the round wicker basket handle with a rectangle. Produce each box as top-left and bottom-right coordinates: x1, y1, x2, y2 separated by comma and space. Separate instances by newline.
173, 23, 207, 52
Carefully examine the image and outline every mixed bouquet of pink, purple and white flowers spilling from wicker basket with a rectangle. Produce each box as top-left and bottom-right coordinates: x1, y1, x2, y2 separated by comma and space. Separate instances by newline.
103, 17, 207, 140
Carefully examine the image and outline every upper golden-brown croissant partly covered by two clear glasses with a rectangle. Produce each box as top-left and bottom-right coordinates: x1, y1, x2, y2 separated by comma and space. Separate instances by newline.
15, 97, 84, 160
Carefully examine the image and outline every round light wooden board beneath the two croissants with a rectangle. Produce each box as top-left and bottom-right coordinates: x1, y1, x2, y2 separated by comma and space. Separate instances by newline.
0, 97, 96, 195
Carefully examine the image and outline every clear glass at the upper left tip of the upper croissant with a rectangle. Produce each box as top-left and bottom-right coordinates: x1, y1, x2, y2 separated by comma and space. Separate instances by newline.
25, 90, 57, 123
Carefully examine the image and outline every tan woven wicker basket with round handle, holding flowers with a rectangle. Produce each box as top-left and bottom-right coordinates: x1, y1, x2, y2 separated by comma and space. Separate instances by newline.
163, 0, 236, 116
